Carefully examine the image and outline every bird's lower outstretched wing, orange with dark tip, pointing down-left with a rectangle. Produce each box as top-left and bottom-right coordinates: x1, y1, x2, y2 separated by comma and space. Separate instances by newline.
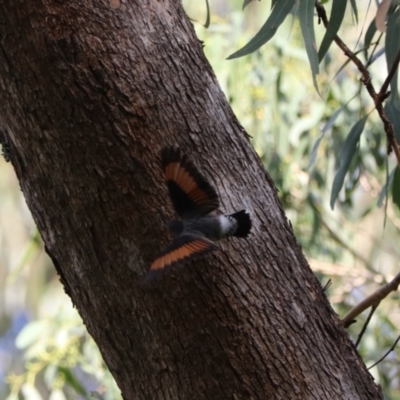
145, 234, 217, 282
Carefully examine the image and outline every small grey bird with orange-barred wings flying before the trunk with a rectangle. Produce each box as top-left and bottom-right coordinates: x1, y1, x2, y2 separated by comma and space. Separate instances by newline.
146, 147, 251, 281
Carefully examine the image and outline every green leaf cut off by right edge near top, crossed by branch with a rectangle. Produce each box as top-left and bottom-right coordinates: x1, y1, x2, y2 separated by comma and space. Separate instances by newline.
385, 9, 400, 97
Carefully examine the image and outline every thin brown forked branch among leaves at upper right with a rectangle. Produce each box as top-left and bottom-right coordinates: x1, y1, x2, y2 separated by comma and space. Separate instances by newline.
315, 1, 400, 166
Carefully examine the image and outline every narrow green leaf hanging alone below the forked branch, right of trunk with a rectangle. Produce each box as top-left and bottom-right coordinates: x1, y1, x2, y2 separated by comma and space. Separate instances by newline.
330, 116, 368, 210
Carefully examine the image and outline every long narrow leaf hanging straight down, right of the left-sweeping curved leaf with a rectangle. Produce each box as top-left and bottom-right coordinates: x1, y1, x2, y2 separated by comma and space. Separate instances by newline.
298, 0, 319, 93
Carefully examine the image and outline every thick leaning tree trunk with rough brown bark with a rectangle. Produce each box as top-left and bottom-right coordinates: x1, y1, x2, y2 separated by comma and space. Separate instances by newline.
0, 0, 382, 400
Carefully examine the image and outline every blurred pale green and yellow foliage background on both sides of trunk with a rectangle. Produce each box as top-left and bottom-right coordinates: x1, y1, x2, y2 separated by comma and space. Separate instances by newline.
0, 0, 400, 400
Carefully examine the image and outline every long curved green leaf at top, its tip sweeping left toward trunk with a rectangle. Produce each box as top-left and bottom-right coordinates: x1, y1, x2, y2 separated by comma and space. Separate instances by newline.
228, 0, 295, 60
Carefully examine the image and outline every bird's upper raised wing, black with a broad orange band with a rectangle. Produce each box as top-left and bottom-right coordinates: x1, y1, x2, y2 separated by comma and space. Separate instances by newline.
161, 147, 219, 218
